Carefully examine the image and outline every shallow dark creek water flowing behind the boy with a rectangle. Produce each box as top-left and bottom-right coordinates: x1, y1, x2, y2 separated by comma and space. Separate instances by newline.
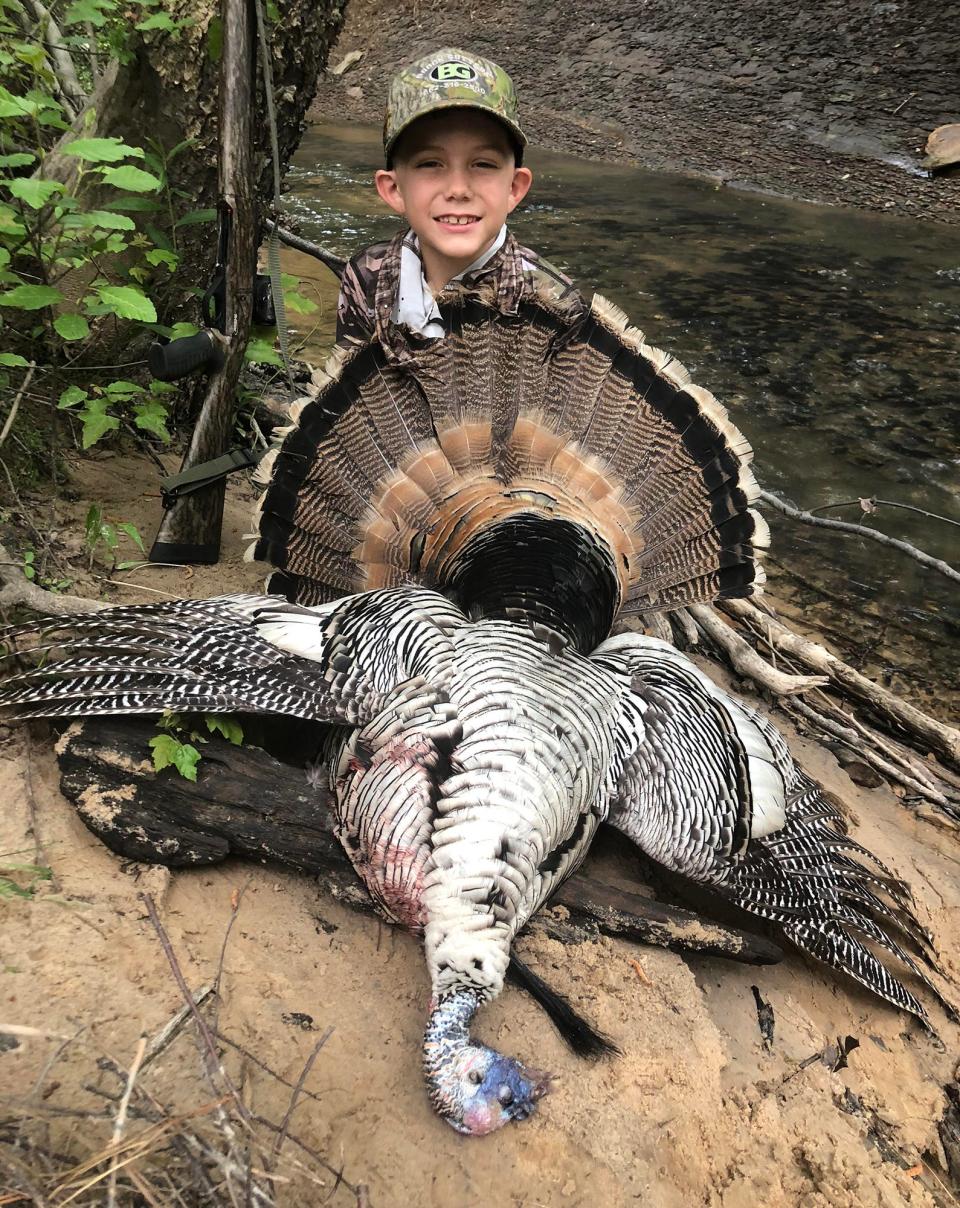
277, 126, 960, 713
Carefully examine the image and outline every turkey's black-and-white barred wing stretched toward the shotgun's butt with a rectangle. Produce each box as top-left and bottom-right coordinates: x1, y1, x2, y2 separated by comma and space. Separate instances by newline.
0, 587, 465, 725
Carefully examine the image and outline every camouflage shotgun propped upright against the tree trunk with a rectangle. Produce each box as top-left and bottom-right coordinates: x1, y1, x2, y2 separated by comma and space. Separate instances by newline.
150, 0, 257, 563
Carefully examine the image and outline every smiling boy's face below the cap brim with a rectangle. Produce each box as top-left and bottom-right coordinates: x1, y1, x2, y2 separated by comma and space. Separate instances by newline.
376, 109, 534, 292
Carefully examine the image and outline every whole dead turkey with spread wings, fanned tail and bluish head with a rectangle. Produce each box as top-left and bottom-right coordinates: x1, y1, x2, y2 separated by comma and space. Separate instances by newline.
2, 282, 936, 1134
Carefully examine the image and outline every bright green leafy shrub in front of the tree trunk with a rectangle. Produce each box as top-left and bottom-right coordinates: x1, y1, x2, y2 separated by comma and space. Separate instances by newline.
0, 0, 209, 448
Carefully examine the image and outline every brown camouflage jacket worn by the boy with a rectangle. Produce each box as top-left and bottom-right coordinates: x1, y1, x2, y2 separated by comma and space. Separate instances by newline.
337, 231, 586, 362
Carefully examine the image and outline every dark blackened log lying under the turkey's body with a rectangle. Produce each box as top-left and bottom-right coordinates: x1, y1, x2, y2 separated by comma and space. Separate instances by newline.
57, 718, 782, 964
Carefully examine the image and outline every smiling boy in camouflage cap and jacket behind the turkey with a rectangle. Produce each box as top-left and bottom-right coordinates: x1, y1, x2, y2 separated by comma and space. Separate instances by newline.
337, 48, 583, 364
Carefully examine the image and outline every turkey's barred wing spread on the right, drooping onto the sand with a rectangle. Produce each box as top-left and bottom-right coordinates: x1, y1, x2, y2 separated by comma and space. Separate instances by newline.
592, 634, 956, 1027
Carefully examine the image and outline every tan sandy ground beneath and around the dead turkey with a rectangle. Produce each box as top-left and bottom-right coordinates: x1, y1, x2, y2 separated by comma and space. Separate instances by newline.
0, 455, 960, 1208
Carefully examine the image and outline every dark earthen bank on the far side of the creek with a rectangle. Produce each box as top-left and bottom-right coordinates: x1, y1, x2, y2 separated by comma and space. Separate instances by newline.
310, 0, 960, 222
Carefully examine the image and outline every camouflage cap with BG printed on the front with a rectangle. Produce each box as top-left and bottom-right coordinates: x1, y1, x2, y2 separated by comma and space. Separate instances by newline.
383, 47, 526, 162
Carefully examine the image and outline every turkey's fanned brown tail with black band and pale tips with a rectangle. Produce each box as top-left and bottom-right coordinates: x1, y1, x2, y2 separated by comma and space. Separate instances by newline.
250, 289, 768, 650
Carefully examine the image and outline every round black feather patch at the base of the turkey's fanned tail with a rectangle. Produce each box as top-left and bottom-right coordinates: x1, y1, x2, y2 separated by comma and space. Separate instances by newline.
444, 511, 619, 654
